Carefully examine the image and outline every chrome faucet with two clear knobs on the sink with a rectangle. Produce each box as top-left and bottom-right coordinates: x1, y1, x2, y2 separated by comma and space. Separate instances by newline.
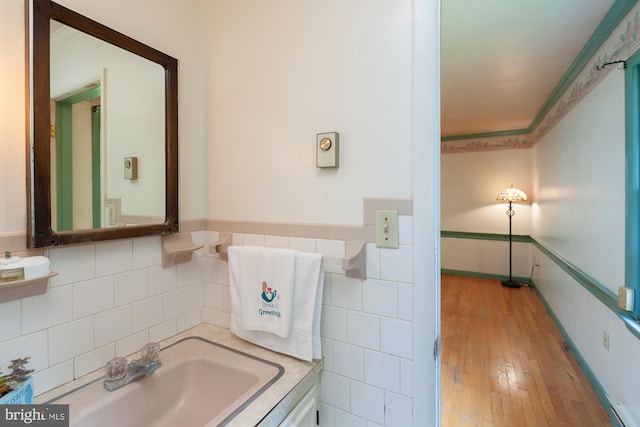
104, 343, 161, 391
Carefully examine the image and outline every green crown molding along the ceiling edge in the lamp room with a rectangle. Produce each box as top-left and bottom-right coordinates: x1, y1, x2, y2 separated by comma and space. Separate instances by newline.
440, 0, 638, 142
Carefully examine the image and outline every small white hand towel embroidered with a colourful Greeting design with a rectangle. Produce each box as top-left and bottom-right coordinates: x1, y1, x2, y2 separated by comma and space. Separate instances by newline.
239, 246, 296, 338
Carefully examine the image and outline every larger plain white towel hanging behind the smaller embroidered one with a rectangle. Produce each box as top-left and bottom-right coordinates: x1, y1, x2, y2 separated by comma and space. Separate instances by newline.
228, 246, 324, 361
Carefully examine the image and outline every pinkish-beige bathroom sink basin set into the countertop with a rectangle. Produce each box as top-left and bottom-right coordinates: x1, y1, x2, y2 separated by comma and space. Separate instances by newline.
48, 337, 284, 427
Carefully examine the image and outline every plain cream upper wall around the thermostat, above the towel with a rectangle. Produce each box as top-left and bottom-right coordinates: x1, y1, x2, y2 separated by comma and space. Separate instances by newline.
204, 0, 413, 224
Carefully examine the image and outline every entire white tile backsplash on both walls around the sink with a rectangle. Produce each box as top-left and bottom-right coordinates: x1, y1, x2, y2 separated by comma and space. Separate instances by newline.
0, 215, 415, 426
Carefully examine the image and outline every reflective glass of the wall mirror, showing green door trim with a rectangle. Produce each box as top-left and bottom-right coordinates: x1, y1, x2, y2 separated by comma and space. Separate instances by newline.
50, 20, 165, 231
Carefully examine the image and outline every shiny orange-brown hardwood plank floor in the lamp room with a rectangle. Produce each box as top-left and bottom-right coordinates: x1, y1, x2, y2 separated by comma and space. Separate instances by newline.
441, 275, 611, 427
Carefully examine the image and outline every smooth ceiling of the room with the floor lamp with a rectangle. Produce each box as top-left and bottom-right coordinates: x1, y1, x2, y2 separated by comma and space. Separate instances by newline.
441, 0, 615, 136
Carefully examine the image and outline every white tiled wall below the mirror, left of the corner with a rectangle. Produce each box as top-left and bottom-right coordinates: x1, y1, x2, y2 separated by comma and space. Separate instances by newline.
0, 236, 204, 395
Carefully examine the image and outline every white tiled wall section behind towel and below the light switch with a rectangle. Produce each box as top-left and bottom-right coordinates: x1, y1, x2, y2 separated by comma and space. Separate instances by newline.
202, 216, 414, 427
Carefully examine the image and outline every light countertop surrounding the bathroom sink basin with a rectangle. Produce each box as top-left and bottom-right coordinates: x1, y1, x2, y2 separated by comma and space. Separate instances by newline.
35, 323, 324, 427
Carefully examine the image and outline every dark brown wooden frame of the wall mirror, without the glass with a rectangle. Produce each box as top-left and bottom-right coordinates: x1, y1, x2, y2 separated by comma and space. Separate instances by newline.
26, 0, 179, 248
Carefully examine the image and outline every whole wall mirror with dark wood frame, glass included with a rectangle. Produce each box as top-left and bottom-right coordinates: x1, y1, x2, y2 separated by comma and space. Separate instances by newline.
27, 0, 179, 248
